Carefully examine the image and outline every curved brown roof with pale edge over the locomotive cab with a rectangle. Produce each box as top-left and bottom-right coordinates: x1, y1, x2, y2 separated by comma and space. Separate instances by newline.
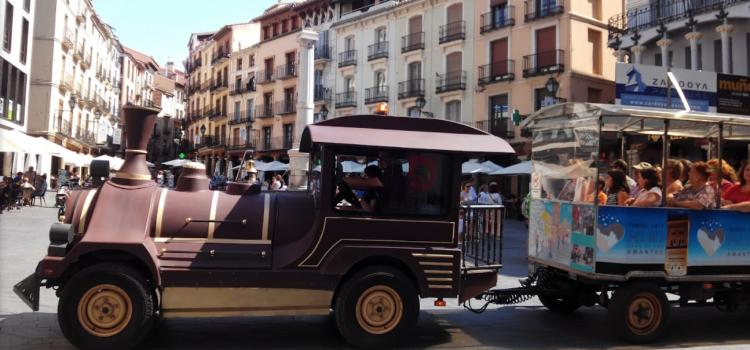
300, 115, 515, 153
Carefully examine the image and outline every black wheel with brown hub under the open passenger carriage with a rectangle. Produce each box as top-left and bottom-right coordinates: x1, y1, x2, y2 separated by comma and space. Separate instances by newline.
607, 282, 670, 344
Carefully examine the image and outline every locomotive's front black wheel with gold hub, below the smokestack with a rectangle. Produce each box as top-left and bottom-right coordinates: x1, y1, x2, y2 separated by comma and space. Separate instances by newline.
57, 263, 156, 349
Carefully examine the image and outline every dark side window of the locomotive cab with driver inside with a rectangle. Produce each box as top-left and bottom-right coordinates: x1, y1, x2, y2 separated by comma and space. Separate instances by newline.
333, 150, 451, 216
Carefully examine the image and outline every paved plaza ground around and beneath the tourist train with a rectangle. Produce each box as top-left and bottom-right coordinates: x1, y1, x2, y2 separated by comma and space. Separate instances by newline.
0, 196, 750, 350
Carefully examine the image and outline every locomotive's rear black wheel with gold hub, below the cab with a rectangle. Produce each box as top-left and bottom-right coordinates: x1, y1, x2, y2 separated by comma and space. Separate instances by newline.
334, 266, 419, 349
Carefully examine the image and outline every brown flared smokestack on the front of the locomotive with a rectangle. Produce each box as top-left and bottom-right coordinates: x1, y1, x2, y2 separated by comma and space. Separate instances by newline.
112, 105, 161, 186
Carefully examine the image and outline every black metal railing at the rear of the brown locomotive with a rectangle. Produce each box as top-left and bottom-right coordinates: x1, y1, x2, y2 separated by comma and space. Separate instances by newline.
460, 205, 505, 272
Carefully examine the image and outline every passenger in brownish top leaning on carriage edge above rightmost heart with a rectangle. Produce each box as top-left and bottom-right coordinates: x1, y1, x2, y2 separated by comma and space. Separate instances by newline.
667, 162, 716, 210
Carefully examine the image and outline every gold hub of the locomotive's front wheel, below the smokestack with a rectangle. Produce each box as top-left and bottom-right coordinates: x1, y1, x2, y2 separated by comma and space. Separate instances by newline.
78, 284, 133, 337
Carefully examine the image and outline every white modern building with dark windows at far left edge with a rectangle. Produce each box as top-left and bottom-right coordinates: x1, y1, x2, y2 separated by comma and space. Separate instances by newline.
0, 0, 36, 175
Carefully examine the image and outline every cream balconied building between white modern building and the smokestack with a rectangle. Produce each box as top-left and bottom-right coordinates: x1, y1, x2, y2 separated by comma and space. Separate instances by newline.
27, 0, 120, 172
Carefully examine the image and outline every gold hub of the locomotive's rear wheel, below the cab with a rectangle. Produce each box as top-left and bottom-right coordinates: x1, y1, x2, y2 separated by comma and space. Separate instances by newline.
357, 286, 403, 334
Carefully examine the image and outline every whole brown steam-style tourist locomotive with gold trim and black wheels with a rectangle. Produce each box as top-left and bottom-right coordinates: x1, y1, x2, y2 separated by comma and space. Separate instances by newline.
15, 106, 512, 349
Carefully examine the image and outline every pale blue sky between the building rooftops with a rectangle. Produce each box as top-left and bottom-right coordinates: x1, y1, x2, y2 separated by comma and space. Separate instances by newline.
93, 0, 277, 70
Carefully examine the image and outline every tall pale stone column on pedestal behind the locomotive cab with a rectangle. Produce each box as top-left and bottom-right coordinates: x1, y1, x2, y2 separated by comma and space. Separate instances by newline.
288, 27, 318, 190
